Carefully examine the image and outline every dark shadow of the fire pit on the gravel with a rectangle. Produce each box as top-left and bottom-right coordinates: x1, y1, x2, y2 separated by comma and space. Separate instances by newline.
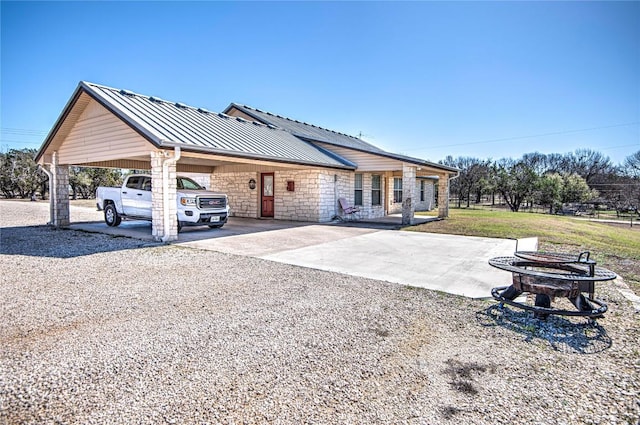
476, 304, 612, 354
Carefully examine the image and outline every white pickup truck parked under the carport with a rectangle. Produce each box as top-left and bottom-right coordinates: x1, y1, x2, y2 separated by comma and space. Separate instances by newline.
96, 174, 229, 230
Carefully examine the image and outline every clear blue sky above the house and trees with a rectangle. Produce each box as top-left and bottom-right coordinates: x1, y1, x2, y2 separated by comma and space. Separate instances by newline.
0, 1, 640, 163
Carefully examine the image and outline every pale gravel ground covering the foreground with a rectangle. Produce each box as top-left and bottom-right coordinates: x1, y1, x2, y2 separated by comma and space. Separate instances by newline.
0, 201, 640, 425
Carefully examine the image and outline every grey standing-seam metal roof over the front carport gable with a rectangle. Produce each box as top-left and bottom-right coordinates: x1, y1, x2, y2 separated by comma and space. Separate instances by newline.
38, 81, 356, 169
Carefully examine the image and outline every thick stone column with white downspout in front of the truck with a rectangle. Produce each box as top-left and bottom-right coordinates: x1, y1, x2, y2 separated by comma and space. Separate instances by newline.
151, 152, 178, 242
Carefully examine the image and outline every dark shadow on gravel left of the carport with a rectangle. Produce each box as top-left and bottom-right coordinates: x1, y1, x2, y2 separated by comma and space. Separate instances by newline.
0, 226, 161, 258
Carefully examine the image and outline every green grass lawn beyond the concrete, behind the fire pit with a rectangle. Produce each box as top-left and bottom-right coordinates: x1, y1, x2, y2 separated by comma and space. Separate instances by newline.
406, 209, 640, 294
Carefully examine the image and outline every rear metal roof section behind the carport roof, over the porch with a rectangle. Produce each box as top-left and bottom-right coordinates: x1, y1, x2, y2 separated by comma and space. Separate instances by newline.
224, 103, 459, 173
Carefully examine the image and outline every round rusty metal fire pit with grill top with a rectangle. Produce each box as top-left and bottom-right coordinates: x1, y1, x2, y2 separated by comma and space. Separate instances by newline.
489, 251, 617, 319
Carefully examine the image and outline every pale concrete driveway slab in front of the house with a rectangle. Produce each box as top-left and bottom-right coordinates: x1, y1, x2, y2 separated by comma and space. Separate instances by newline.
72, 212, 516, 298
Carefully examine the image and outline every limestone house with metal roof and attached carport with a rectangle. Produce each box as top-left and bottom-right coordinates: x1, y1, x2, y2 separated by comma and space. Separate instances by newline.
36, 81, 458, 240
